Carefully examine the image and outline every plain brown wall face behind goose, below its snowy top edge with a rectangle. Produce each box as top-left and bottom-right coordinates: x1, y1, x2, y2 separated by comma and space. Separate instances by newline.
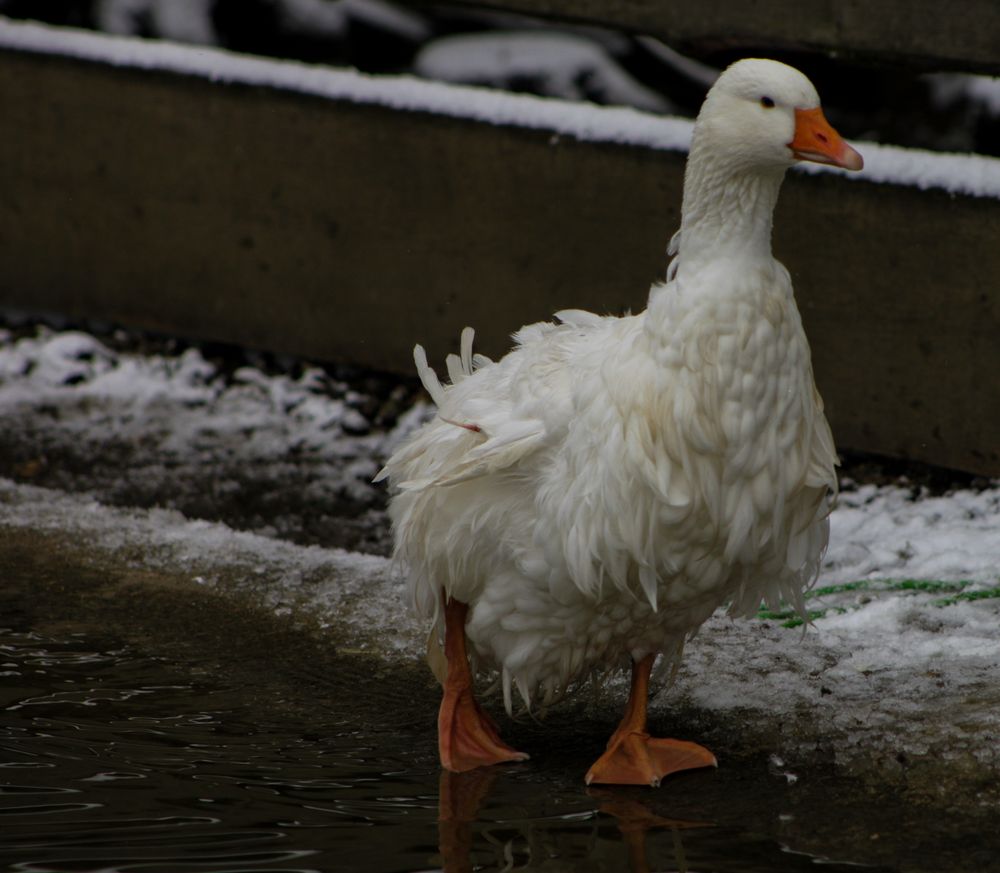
0, 46, 1000, 475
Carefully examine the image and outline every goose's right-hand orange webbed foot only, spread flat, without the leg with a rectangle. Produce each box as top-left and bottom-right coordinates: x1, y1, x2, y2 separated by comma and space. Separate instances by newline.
586, 731, 718, 788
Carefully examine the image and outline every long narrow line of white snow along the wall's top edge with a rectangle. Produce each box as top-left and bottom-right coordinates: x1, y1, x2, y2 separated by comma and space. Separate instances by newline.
0, 17, 1000, 199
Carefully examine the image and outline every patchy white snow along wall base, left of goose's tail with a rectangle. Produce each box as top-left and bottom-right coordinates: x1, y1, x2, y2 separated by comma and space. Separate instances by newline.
0, 328, 395, 506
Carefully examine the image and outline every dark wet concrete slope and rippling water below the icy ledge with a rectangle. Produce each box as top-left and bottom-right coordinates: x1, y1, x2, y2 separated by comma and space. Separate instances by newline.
0, 529, 1000, 873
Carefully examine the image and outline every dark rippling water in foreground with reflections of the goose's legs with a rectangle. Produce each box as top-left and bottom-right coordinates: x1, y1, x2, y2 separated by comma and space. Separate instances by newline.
0, 615, 896, 873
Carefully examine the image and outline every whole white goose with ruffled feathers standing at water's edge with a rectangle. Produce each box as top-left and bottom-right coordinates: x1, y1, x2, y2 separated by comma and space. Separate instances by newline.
379, 59, 862, 785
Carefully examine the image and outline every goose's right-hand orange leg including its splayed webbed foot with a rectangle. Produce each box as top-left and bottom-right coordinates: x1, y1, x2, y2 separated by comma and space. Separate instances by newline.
587, 655, 716, 788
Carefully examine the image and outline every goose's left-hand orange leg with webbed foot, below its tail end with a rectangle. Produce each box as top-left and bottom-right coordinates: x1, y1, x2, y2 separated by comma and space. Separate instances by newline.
438, 598, 528, 773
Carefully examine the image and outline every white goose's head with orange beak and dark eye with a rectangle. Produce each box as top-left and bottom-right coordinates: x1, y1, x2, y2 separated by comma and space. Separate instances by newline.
695, 58, 864, 170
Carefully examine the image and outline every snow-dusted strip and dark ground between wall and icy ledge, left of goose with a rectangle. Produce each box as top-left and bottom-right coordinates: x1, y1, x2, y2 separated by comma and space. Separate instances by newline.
0, 329, 423, 552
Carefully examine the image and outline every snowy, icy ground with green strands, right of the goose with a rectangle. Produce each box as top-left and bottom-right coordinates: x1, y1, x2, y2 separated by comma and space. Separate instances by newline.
672, 484, 1000, 776
